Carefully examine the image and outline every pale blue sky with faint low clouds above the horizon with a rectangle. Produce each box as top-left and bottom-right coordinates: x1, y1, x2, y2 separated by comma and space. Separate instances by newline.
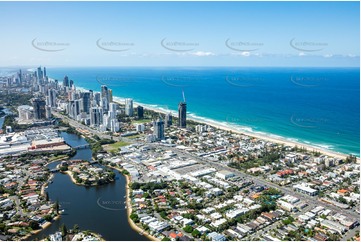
0, 2, 360, 67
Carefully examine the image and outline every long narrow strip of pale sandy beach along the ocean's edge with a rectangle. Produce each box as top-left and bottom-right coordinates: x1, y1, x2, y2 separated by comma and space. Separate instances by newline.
114, 97, 352, 161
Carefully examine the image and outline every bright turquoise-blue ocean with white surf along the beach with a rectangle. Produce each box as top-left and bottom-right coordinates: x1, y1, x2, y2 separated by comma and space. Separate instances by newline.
7, 67, 360, 156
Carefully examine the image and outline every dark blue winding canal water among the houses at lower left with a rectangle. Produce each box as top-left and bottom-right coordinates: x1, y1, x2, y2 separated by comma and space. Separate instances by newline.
31, 132, 147, 241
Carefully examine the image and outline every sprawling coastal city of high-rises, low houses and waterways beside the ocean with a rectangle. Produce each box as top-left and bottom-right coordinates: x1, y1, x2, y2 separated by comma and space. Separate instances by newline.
0, 67, 360, 241
